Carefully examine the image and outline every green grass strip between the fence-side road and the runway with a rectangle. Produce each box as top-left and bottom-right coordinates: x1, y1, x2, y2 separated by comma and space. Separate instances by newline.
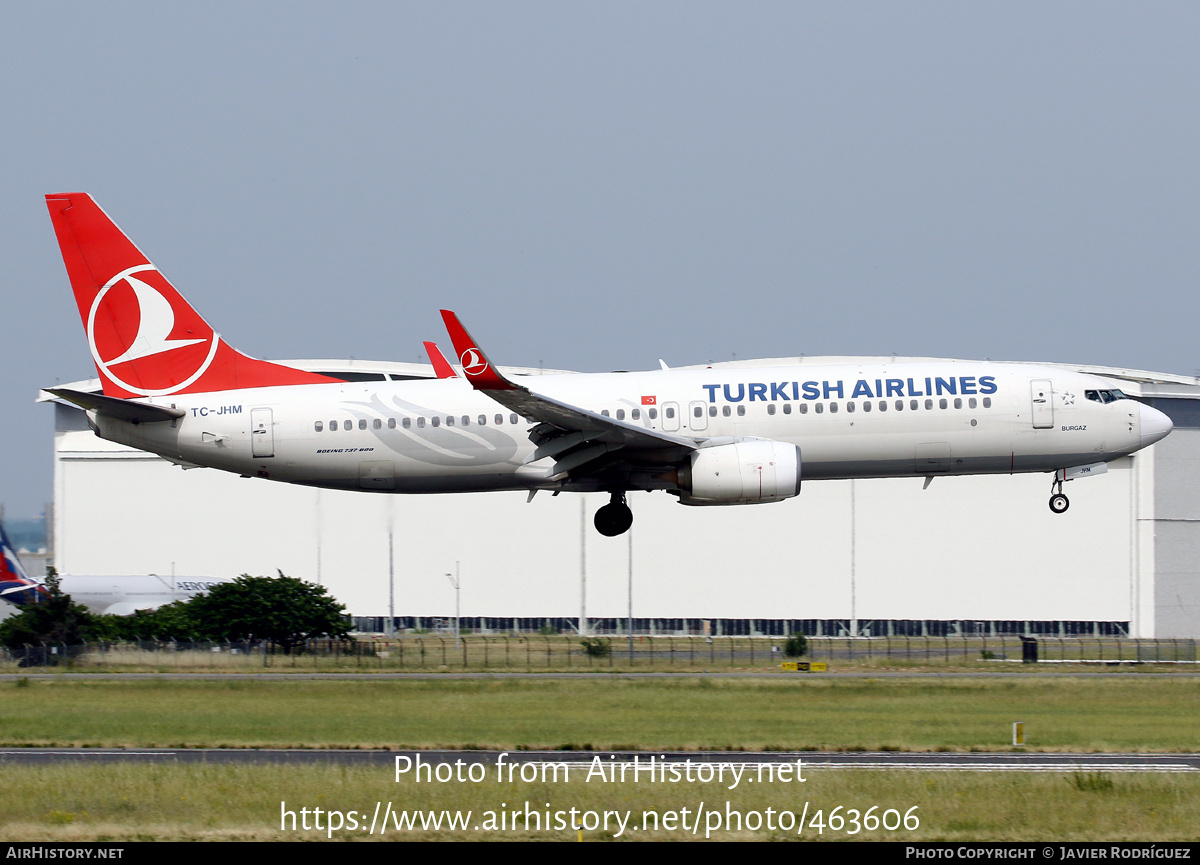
0, 675, 1200, 751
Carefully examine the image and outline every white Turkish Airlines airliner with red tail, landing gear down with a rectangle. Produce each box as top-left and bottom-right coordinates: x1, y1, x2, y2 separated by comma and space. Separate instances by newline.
47, 193, 1171, 536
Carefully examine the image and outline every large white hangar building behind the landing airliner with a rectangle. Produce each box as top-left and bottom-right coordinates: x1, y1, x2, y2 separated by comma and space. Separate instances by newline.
40, 358, 1200, 637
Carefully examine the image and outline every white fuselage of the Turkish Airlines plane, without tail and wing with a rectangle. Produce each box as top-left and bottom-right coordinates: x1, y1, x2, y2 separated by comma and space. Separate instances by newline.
94, 361, 1153, 493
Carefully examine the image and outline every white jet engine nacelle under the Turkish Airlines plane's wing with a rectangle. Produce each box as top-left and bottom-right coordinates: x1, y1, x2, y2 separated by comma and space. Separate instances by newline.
679, 438, 800, 505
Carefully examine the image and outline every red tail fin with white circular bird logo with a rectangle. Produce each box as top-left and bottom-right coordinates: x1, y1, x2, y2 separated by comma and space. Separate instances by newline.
46, 192, 336, 398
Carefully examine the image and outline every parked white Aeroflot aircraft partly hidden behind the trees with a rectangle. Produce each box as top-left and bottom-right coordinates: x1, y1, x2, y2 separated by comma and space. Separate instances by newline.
0, 525, 229, 615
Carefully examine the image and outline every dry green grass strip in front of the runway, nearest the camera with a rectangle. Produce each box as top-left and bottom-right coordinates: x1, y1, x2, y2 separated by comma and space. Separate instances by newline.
0, 763, 1200, 841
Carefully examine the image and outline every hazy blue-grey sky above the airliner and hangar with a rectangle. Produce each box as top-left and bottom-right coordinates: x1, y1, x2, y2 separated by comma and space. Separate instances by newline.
0, 1, 1200, 516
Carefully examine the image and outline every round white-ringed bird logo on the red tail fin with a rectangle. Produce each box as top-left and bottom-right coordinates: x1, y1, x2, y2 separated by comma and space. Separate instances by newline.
88, 264, 220, 396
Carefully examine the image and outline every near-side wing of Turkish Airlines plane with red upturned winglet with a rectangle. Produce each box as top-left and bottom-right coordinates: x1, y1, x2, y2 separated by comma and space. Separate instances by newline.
442, 310, 697, 474
